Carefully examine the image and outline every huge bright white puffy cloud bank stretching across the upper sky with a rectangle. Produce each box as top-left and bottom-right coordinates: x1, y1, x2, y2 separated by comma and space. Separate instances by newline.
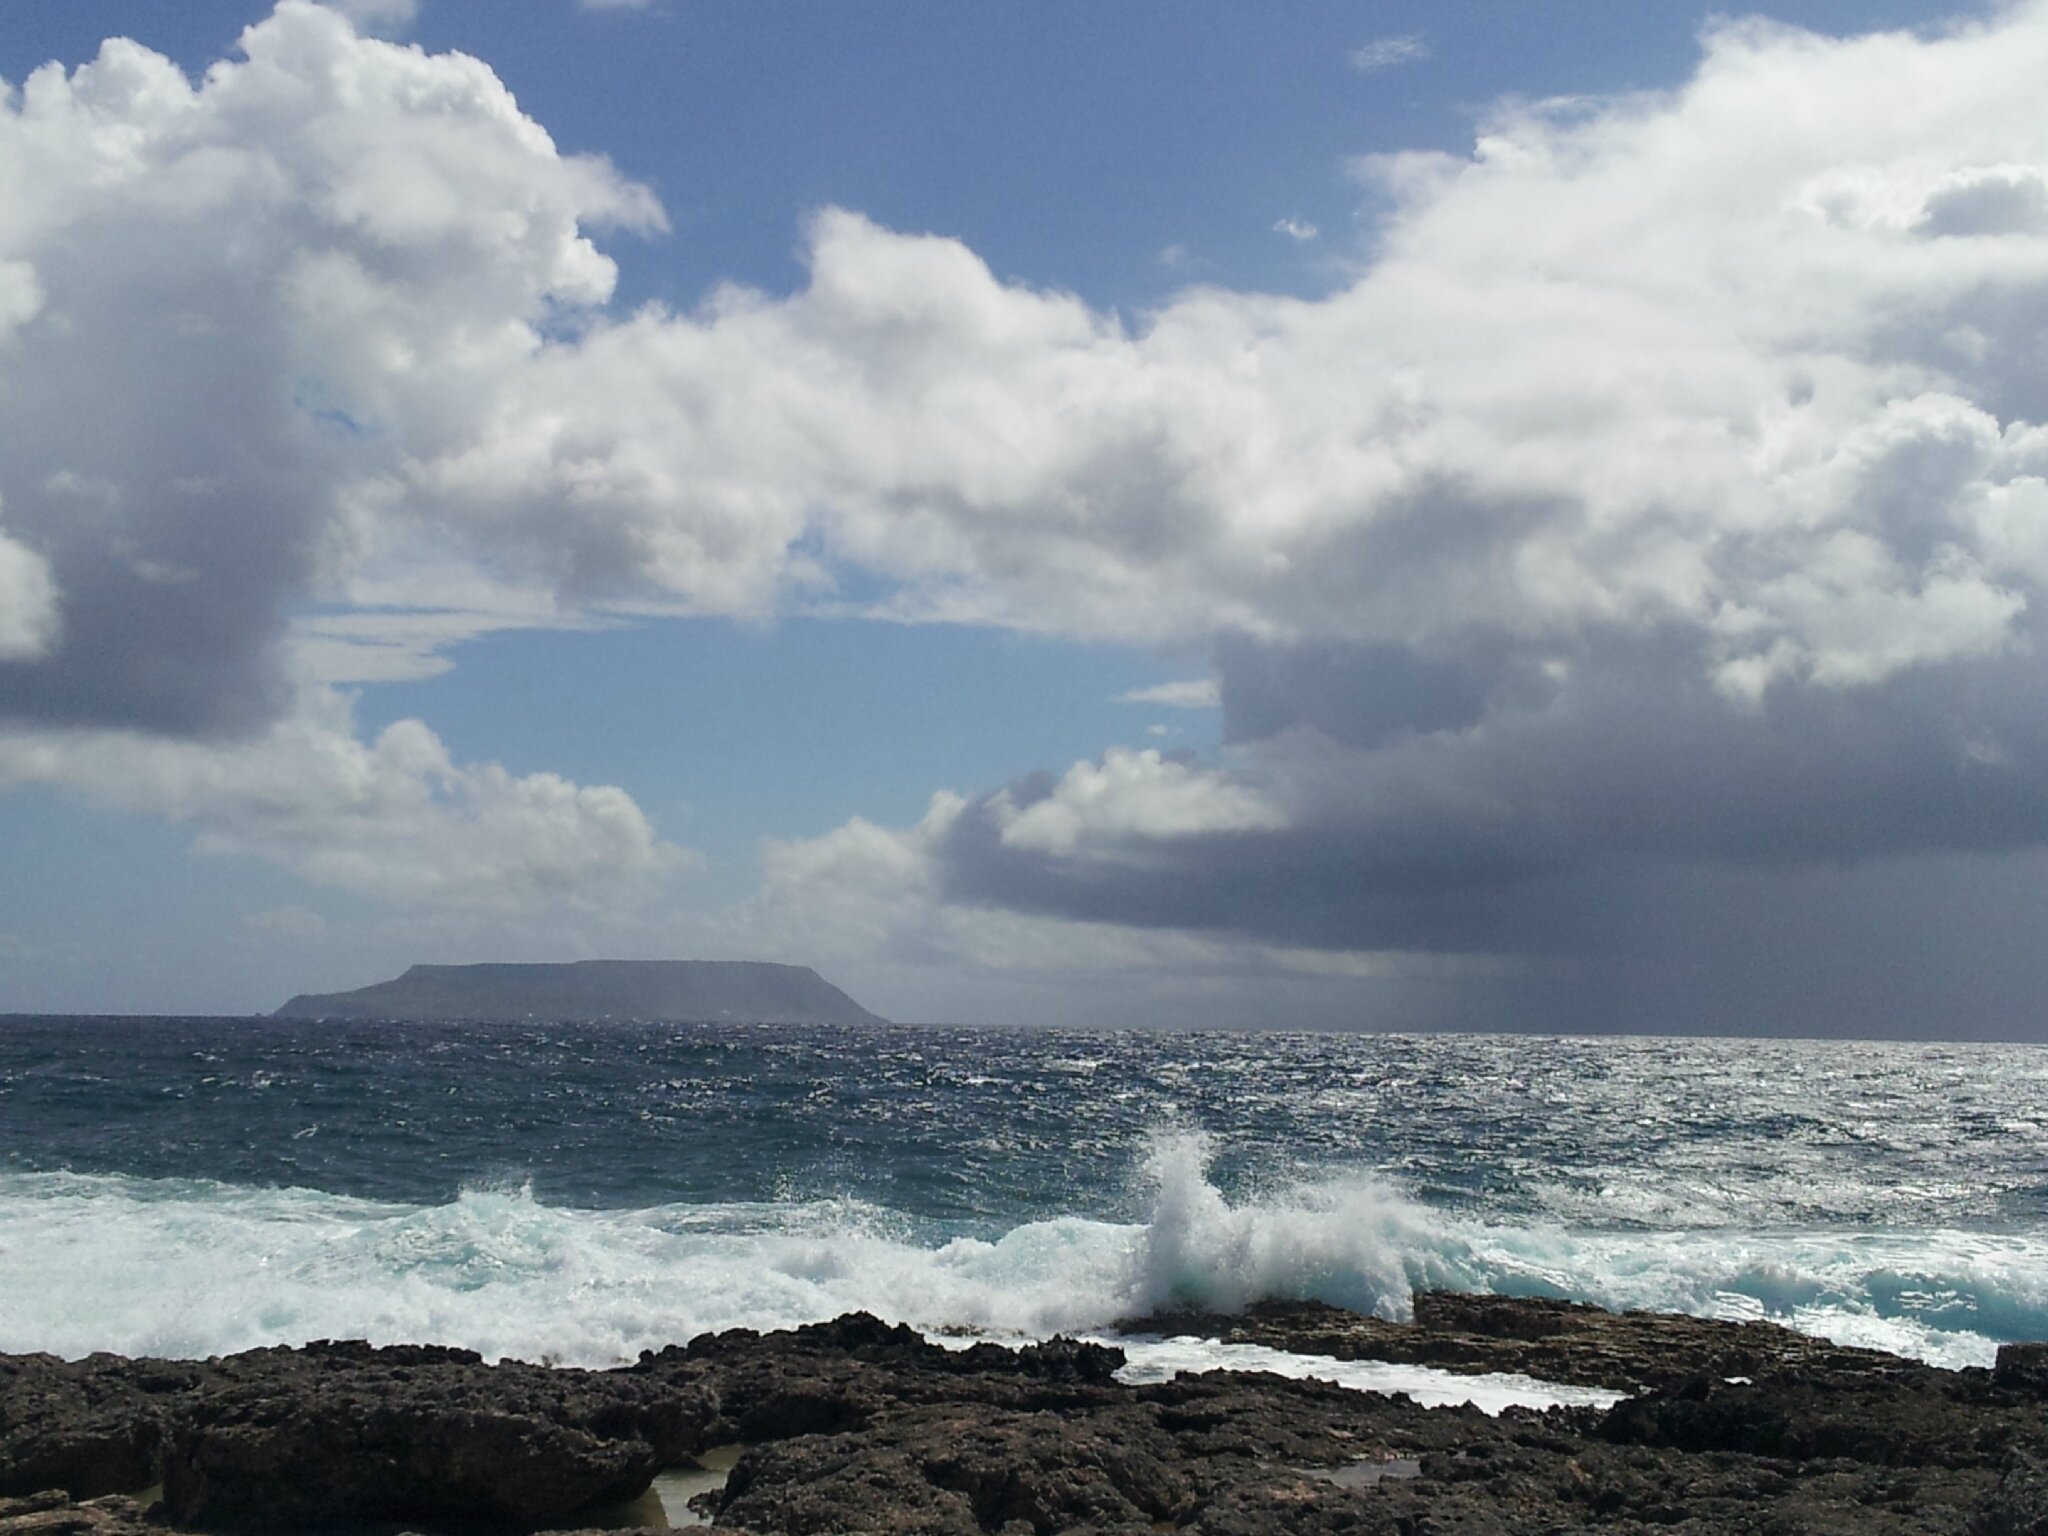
16, 0, 2048, 713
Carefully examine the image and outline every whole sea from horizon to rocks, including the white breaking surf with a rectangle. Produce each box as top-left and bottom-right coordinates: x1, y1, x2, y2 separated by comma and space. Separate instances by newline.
0, 1018, 2048, 1364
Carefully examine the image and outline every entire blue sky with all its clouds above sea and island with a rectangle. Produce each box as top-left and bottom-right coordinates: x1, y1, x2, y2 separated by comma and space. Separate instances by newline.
0, 0, 2048, 1038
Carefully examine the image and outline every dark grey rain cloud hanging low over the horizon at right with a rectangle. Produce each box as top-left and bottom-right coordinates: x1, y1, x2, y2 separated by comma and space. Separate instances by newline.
905, 614, 2048, 1034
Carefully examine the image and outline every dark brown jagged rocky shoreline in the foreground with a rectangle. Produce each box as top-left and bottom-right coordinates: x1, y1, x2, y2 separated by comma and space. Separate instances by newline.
0, 1294, 2048, 1536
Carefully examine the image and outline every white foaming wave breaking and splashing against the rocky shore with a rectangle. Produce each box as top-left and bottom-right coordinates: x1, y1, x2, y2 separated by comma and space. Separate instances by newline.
0, 1135, 2048, 1366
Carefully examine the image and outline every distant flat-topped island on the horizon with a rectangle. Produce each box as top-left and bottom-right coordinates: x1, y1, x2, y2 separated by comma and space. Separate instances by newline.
270, 961, 889, 1024
